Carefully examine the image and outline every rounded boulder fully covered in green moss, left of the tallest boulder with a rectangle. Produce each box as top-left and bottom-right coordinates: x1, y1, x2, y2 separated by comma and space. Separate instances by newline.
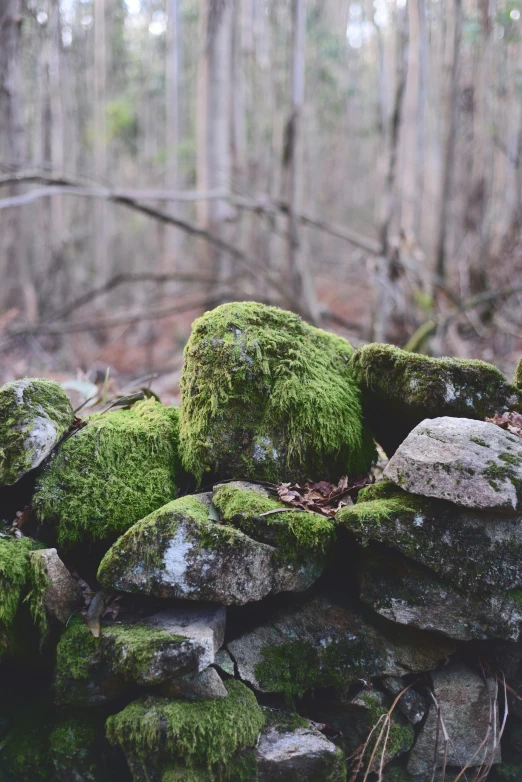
33, 399, 180, 548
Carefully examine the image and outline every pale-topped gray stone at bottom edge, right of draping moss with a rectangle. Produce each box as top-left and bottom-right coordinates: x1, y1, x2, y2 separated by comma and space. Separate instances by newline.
255, 720, 346, 782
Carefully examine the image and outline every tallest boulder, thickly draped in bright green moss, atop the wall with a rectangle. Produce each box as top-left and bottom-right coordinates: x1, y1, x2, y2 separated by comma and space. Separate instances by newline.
180, 302, 375, 481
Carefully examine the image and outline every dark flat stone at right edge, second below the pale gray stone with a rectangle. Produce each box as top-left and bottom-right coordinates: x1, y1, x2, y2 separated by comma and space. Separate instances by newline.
361, 549, 522, 641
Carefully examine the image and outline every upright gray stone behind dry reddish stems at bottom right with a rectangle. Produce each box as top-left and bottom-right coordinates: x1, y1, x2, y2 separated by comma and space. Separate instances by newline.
408, 664, 500, 775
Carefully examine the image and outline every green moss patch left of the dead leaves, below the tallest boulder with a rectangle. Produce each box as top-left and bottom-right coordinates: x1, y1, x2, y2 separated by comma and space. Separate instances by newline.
213, 484, 335, 561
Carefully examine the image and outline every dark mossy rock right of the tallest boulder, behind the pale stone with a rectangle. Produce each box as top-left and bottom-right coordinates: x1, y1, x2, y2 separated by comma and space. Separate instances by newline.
351, 343, 522, 456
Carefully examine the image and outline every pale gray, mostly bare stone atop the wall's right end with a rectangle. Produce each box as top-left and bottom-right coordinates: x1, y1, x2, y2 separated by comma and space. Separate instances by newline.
384, 417, 522, 513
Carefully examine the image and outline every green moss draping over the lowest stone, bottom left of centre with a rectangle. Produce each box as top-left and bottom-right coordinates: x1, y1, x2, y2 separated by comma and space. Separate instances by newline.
107, 680, 264, 781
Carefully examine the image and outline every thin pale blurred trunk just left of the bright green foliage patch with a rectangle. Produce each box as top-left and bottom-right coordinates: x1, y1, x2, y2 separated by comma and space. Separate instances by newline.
94, 0, 109, 296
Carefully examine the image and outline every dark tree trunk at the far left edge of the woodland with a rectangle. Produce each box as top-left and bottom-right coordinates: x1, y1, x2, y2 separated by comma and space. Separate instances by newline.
0, 0, 38, 321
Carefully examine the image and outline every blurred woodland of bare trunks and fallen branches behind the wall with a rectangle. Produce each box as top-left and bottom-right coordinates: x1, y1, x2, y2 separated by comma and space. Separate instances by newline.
0, 0, 522, 401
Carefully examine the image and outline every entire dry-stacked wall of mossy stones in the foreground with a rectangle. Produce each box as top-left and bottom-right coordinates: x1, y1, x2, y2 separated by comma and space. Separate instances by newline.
0, 304, 522, 782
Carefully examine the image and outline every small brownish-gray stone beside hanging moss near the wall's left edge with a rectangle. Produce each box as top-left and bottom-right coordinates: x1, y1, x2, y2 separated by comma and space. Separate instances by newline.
30, 548, 82, 624
